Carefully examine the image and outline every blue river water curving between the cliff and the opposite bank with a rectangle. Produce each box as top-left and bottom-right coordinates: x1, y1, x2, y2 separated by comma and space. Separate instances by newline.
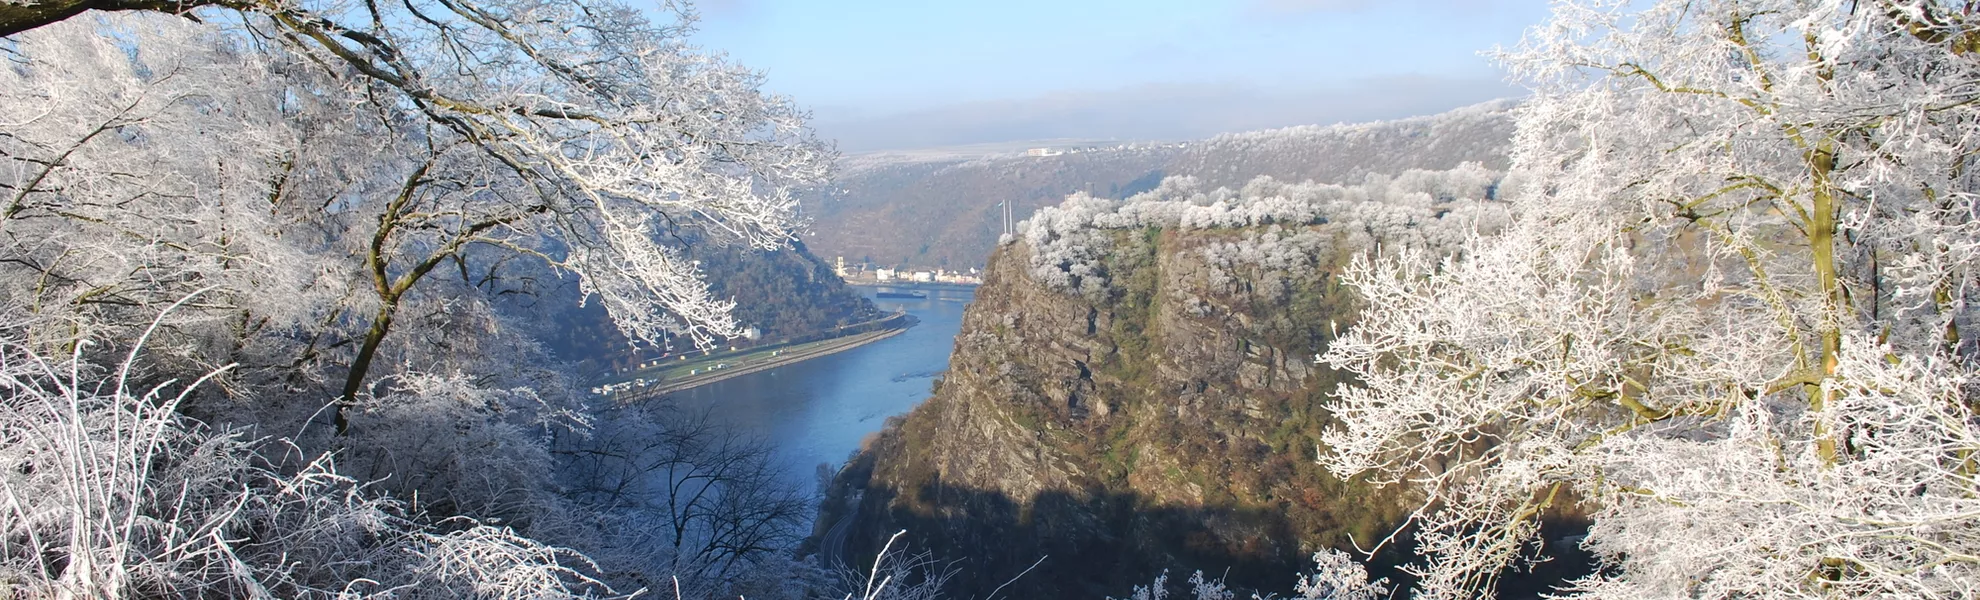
671, 287, 974, 491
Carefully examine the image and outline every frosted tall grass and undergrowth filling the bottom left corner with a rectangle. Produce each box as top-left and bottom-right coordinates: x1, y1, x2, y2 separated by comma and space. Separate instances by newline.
0, 327, 616, 598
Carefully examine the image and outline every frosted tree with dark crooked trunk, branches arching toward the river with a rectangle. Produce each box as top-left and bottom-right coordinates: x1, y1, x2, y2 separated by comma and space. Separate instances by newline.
0, 2, 832, 426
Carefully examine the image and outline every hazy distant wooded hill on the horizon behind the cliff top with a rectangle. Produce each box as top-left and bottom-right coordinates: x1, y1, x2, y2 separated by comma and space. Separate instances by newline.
804, 101, 1517, 269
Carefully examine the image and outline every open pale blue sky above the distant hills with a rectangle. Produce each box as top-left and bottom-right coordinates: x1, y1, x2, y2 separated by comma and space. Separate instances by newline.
695, 0, 1546, 152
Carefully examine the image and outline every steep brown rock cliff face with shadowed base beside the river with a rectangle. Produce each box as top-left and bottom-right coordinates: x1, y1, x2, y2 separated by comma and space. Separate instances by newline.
822, 224, 1414, 598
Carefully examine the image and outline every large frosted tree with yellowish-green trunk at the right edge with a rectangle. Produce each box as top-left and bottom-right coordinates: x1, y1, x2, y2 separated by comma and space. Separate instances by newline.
1321, 0, 1980, 598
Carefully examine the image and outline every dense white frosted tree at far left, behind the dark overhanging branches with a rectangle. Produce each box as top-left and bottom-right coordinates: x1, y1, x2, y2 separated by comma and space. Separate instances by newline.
0, 16, 356, 409
